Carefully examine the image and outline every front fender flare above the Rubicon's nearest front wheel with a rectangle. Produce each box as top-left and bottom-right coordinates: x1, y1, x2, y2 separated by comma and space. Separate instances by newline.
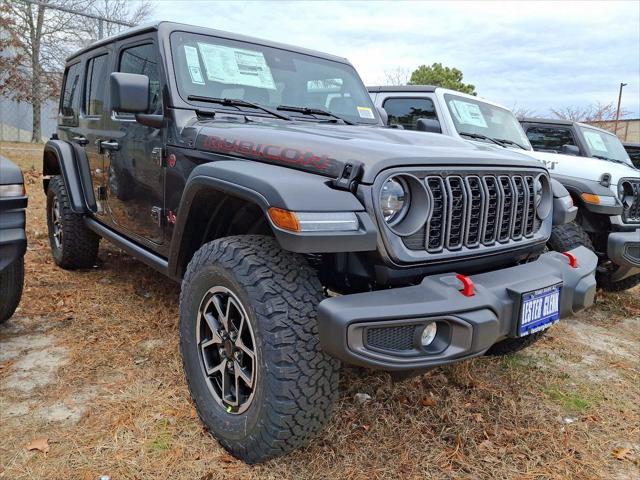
169, 160, 377, 278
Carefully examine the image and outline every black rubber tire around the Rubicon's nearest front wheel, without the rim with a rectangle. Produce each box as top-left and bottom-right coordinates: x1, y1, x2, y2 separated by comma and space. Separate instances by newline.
180, 235, 340, 463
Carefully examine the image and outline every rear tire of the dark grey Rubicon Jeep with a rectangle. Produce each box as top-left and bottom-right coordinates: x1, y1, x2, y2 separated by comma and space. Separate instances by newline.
47, 176, 100, 270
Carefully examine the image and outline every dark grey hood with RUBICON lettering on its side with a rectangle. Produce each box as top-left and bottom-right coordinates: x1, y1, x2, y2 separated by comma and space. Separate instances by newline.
188, 118, 541, 183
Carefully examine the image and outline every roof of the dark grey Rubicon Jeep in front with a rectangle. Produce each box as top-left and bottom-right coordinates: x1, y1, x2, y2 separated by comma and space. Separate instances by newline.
67, 21, 351, 65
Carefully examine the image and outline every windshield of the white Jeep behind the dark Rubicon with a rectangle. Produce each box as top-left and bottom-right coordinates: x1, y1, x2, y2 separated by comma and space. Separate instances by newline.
444, 94, 531, 150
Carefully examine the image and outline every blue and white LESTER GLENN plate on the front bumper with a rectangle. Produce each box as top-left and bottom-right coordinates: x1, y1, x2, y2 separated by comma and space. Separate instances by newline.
518, 285, 561, 337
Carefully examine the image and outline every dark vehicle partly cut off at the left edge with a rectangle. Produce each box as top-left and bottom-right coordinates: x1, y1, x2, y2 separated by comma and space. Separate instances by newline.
0, 156, 27, 323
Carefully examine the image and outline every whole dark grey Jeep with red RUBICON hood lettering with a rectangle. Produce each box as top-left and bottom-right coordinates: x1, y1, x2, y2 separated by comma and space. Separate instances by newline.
43, 22, 597, 463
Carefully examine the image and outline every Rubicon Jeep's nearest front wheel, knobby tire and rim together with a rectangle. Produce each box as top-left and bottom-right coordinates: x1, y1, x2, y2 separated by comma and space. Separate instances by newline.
180, 235, 340, 463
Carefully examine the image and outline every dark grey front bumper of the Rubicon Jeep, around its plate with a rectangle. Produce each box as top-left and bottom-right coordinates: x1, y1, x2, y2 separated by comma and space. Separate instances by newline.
318, 247, 598, 371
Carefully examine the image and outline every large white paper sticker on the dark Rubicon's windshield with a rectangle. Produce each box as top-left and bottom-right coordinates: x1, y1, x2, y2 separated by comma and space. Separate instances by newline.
198, 42, 276, 90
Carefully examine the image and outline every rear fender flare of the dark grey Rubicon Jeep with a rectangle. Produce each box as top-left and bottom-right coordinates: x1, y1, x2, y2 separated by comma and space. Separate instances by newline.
42, 140, 96, 214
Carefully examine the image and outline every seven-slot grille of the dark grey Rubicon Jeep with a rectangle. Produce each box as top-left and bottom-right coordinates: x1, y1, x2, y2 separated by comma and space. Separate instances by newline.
402, 172, 540, 253
